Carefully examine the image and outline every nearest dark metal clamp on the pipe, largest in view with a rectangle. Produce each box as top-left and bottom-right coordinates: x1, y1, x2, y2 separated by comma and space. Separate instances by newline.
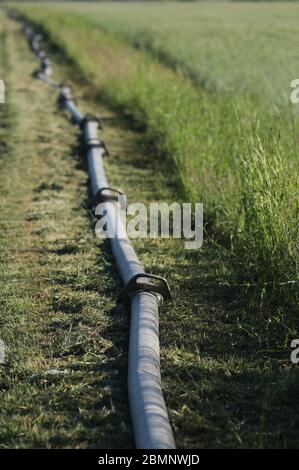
117, 273, 171, 302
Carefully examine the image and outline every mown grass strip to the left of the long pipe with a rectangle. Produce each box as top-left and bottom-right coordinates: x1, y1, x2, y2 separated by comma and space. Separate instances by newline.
0, 14, 132, 448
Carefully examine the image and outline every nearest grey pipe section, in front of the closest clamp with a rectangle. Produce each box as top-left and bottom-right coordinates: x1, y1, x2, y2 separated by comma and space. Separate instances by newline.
128, 292, 175, 449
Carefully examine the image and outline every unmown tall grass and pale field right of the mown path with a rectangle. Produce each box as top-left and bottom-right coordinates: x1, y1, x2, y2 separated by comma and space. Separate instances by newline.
11, 3, 299, 312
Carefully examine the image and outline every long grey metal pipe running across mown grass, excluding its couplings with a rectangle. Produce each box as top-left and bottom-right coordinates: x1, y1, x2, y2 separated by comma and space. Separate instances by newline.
21, 21, 175, 449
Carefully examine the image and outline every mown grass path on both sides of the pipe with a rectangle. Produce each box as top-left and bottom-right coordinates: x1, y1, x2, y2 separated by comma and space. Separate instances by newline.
0, 11, 299, 448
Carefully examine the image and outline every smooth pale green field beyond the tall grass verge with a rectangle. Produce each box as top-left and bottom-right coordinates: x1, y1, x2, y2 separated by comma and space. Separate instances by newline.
68, 2, 299, 103
